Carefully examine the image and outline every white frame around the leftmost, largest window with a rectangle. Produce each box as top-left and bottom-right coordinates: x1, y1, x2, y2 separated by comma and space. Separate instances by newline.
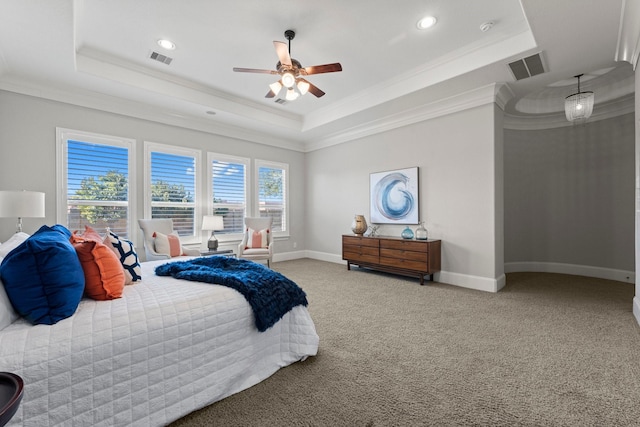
56, 127, 137, 242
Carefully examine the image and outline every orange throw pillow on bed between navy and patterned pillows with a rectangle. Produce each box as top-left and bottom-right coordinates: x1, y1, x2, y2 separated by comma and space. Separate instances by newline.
70, 226, 125, 301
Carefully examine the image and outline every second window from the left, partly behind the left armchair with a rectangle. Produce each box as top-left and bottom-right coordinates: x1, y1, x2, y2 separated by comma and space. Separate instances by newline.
145, 142, 200, 243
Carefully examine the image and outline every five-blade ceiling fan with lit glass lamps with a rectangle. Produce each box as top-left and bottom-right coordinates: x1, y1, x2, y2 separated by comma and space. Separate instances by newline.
233, 30, 342, 101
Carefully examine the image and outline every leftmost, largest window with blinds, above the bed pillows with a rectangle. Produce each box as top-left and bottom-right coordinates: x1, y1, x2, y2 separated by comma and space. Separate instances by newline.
56, 128, 135, 238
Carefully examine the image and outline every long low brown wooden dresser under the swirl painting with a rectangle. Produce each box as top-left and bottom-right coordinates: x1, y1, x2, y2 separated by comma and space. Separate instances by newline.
342, 234, 441, 285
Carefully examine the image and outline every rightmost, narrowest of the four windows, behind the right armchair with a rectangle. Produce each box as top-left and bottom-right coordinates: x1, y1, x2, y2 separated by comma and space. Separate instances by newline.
256, 160, 289, 236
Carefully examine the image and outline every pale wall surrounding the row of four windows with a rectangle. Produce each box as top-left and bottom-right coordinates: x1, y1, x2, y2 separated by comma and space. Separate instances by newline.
0, 91, 305, 253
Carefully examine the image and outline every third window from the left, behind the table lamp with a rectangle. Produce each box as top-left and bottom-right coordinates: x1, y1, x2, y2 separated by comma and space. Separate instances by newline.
207, 153, 249, 235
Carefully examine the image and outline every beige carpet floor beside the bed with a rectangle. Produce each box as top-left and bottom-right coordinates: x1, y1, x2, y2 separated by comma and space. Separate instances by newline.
172, 259, 640, 427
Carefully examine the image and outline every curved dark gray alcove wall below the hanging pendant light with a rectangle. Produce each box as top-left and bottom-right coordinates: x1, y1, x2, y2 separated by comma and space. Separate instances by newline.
504, 114, 635, 279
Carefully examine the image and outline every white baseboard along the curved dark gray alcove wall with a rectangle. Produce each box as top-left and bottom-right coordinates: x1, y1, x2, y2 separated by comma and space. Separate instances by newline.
504, 262, 636, 283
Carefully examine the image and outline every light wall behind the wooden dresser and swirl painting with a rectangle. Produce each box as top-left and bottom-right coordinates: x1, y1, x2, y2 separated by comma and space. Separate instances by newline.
306, 104, 504, 291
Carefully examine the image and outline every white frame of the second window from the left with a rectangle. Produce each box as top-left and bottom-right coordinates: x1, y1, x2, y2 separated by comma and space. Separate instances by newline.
143, 141, 202, 245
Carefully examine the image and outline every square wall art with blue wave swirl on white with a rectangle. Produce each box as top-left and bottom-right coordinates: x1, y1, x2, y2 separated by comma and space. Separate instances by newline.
369, 167, 420, 224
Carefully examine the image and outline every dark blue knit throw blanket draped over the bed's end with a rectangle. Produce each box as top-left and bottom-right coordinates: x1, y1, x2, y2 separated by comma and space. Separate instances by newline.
156, 256, 307, 332
